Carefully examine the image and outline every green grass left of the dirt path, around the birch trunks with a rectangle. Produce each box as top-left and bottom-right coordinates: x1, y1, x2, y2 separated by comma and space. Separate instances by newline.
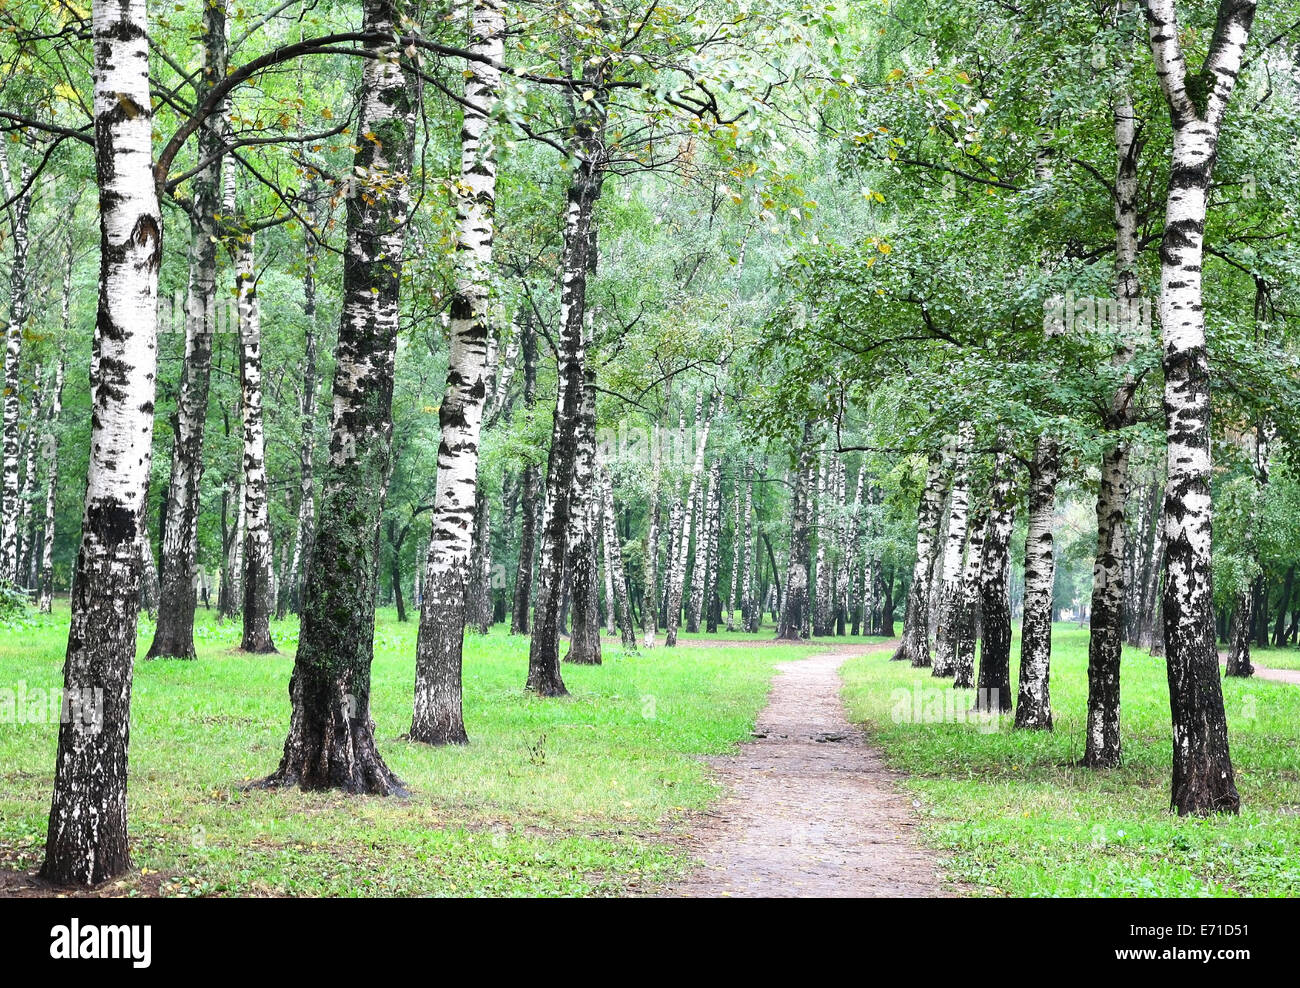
0, 608, 816, 896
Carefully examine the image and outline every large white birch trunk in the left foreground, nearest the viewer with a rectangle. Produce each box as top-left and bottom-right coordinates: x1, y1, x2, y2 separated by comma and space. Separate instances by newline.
40, 0, 163, 887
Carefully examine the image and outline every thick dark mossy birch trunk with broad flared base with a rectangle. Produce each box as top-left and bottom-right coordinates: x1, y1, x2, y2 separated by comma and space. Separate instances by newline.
267, 0, 416, 796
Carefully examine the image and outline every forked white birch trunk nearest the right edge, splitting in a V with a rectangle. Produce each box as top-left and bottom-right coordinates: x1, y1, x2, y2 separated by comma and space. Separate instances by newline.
1145, 0, 1256, 815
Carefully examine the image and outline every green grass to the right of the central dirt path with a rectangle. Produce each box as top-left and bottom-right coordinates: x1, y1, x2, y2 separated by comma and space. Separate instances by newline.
844, 624, 1300, 896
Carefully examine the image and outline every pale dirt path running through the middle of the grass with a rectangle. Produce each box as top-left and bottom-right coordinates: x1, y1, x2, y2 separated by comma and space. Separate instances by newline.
671, 644, 952, 897
